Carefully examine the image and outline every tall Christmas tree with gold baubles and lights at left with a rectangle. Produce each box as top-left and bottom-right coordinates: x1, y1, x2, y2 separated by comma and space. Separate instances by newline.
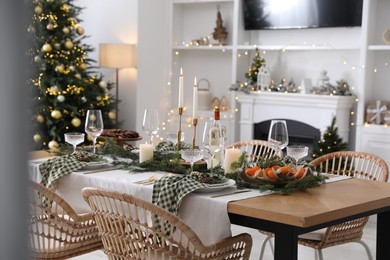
28, 0, 117, 149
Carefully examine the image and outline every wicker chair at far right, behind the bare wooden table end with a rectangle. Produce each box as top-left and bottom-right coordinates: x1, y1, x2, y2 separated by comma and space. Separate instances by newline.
260, 151, 389, 260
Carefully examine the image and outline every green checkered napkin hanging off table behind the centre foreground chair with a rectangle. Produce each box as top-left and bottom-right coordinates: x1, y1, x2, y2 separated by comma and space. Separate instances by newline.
152, 175, 208, 235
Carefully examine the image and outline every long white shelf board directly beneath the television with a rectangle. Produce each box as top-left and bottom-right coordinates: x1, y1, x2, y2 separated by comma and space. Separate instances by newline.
237, 45, 360, 51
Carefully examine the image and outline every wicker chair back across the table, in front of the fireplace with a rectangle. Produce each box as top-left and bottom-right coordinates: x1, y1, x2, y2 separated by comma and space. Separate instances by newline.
226, 140, 283, 162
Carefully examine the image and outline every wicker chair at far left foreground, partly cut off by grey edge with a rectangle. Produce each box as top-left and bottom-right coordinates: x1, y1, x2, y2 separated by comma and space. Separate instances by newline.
28, 181, 103, 259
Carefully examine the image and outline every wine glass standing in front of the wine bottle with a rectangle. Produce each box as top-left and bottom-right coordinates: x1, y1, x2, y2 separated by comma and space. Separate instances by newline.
202, 120, 223, 172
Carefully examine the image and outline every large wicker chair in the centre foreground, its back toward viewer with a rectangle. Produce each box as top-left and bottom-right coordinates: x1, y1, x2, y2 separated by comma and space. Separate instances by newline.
82, 187, 252, 260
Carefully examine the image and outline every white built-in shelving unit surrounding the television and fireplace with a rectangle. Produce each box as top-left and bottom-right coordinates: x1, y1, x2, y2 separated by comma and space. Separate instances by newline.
169, 0, 390, 167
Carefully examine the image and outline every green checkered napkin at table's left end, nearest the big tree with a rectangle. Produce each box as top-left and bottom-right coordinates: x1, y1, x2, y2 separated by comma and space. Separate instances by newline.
39, 154, 88, 189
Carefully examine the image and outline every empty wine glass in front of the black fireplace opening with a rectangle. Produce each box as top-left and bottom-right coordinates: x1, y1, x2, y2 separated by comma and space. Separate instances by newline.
268, 120, 288, 155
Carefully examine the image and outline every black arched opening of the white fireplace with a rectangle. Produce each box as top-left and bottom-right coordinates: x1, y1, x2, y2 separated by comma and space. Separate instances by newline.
254, 118, 321, 160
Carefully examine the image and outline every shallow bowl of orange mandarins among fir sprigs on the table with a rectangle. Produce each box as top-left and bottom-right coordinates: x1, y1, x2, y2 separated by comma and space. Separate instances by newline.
240, 166, 313, 185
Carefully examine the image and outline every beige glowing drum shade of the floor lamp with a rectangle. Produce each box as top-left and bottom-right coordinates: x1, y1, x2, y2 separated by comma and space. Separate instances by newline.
99, 43, 137, 68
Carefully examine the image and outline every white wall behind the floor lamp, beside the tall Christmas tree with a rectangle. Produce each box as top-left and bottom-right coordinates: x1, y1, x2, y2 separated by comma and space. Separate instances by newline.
74, 0, 138, 130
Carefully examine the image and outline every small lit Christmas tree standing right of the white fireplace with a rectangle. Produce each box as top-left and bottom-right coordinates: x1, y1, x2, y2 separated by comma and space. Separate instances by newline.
312, 117, 348, 159
